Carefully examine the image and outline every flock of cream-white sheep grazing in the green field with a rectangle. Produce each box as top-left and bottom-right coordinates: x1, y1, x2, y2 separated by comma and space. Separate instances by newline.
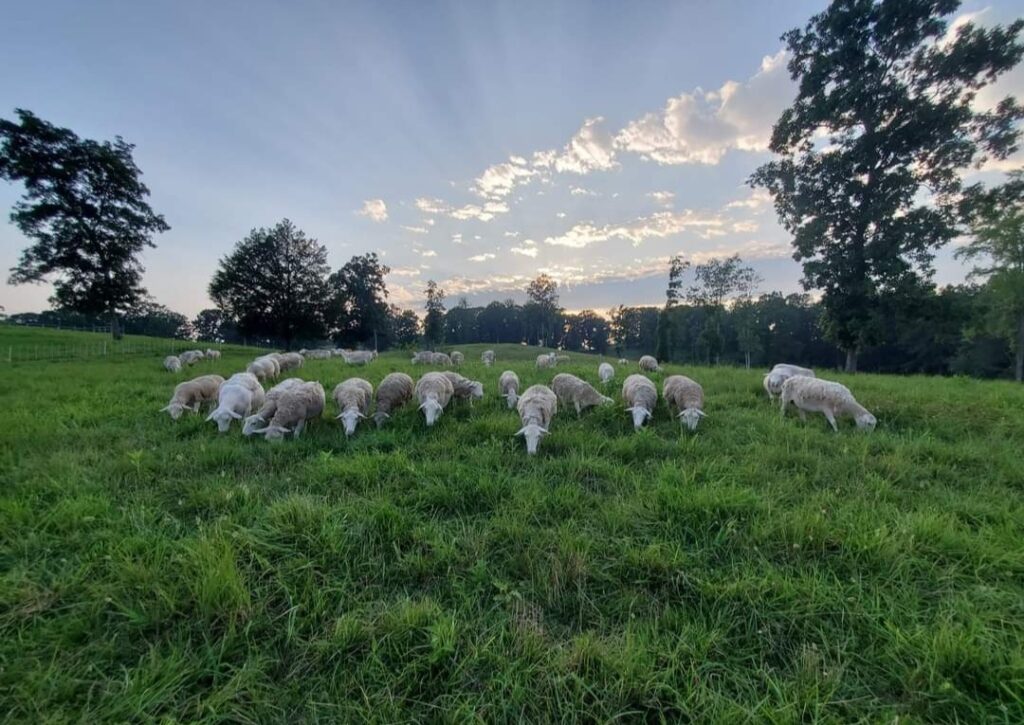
155, 350, 877, 455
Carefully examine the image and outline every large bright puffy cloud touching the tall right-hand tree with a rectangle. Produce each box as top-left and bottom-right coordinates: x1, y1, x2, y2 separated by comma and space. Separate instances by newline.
615, 51, 795, 165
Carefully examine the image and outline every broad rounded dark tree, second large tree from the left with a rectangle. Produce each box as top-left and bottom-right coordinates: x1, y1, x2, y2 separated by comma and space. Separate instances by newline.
210, 219, 330, 349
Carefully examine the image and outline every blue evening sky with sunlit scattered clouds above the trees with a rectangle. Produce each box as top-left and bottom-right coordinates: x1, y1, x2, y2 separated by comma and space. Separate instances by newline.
0, 0, 1024, 315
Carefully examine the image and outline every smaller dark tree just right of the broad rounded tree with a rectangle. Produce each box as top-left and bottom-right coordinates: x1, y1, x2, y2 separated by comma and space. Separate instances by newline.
327, 252, 391, 349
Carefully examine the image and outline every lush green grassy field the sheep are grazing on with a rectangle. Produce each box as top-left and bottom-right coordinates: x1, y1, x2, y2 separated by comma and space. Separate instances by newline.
0, 331, 1024, 723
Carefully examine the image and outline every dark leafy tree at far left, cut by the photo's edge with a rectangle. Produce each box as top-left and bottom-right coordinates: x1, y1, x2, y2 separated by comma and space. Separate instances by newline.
0, 109, 170, 338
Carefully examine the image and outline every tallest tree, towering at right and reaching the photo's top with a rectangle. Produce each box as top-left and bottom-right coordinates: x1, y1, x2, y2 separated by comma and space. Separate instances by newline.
750, 0, 1024, 372
